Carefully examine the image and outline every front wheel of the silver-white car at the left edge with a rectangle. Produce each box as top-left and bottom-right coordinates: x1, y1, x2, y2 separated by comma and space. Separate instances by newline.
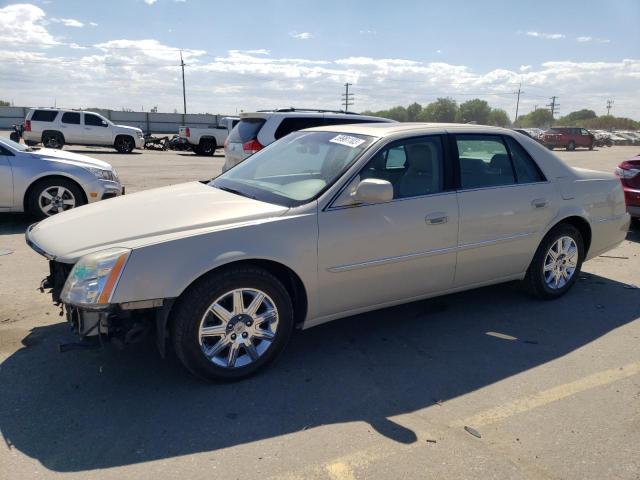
27, 178, 85, 218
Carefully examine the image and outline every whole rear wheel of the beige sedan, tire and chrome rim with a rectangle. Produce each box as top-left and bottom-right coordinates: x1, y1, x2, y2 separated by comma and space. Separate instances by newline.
524, 223, 584, 300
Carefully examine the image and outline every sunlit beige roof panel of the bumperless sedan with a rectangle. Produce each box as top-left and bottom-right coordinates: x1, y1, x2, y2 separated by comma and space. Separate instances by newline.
306, 122, 511, 137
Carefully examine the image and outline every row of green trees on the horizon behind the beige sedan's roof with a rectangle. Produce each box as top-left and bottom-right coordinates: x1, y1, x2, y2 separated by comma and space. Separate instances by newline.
362, 97, 640, 130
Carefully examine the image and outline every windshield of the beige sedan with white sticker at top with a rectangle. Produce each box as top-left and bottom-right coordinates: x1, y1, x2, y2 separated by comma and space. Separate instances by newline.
209, 131, 376, 207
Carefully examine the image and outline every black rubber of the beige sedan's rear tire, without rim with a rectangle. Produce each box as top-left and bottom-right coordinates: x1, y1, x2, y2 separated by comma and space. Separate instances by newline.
523, 223, 584, 300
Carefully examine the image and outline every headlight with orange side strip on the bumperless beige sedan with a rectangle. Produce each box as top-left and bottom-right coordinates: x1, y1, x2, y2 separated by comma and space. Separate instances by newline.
60, 248, 131, 307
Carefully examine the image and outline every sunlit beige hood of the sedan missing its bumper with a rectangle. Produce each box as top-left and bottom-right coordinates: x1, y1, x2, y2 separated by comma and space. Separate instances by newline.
27, 182, 288, 263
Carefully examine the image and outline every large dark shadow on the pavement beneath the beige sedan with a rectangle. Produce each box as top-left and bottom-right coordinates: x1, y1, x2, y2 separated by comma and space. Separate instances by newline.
0, 274, 640, 472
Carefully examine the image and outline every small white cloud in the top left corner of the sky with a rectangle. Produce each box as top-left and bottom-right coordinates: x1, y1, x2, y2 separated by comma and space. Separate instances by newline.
0, 4, 59, 47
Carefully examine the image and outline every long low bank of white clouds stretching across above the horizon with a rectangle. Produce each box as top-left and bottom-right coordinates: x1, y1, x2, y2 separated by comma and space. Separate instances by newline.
0, 38, 640, 118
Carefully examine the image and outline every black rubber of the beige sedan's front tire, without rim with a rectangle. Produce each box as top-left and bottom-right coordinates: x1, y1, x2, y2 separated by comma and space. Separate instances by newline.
171, 266, 294, 381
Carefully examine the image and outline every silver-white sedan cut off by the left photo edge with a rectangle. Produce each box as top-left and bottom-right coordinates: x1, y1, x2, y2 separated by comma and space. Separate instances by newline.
0, 137, 124, 218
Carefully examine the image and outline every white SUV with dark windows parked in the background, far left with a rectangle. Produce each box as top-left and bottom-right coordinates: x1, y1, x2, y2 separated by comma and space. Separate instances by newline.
22, 108, 144, 153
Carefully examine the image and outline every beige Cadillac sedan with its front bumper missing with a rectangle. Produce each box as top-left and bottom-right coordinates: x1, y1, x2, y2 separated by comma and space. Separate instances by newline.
26, 123, 629, 379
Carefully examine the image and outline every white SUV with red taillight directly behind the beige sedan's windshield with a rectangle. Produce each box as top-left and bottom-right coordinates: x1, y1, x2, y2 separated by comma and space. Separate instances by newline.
222, 108, 395, 172
